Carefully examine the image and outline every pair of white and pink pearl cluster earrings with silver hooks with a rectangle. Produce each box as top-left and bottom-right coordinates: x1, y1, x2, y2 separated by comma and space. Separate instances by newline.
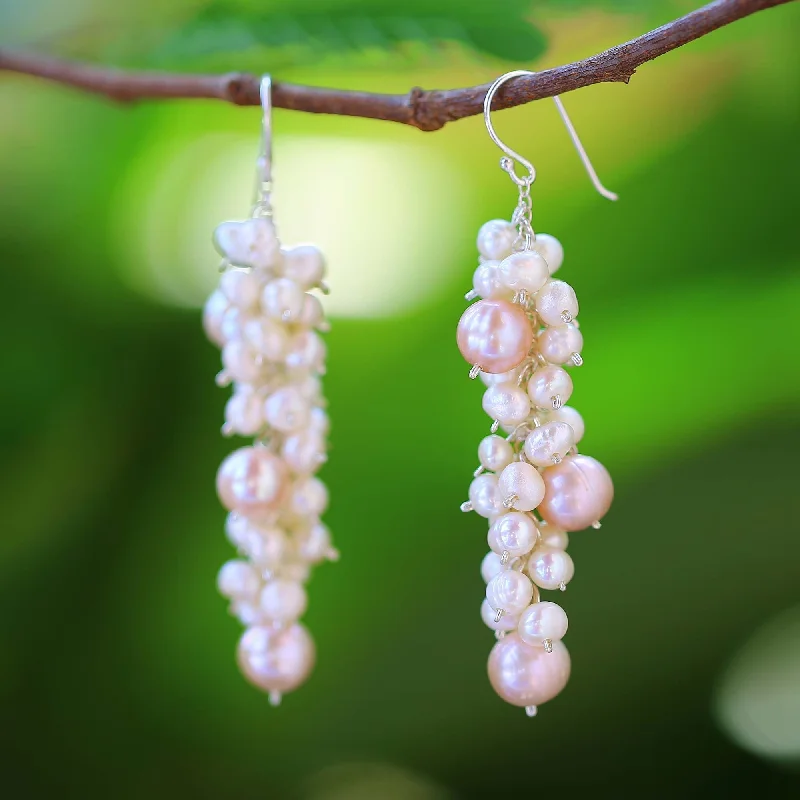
203, 70, 617, 716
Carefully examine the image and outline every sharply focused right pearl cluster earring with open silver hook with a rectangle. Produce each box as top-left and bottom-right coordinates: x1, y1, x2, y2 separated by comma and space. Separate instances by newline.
457, 70, 617, 716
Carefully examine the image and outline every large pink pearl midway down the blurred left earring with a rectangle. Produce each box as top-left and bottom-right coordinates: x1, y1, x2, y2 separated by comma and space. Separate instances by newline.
217, 447, 287, 518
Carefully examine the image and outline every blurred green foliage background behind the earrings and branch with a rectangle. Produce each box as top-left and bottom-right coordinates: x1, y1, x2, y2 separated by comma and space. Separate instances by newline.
0, 0, 800, 800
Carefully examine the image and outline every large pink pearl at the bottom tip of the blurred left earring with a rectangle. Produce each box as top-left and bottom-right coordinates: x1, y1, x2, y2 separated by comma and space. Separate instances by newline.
236, 623, 315, 692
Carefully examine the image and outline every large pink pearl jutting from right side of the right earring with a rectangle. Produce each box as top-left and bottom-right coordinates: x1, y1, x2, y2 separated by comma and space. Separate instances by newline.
539, 455, 614, 531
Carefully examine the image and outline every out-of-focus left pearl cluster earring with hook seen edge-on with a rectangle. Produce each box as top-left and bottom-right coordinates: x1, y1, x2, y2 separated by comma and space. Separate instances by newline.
203, 76, 338, 705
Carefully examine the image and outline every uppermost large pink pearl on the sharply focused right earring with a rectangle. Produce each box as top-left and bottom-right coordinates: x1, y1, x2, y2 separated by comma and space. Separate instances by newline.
457, 300, 533, 373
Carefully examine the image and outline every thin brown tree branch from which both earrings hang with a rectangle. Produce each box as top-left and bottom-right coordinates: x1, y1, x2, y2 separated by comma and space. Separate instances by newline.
0, 0, 791, 131
